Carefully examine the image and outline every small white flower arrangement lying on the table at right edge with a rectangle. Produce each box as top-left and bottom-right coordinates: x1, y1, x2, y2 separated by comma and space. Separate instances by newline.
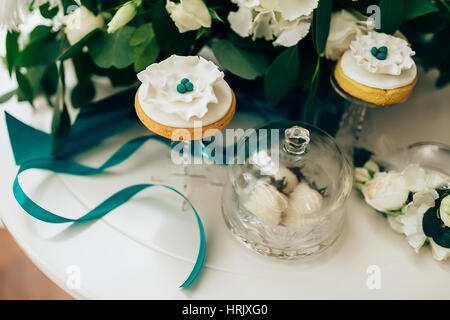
355, 160, 450, 261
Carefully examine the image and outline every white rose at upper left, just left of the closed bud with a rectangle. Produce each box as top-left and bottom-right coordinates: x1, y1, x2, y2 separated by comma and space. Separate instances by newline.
63, 6, 105, 45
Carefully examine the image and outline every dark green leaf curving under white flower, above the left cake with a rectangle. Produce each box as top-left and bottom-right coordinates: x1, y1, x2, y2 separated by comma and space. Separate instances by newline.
152, 0, 196, 57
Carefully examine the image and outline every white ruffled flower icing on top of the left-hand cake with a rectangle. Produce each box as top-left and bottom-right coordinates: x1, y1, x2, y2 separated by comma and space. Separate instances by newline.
138, 55, 224, 121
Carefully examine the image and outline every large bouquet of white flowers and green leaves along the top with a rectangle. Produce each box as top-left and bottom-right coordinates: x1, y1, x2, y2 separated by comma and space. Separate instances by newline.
0, 0, 450, 152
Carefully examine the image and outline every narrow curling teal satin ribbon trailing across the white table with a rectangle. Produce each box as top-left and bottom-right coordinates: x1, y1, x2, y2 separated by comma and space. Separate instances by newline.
13, 135, 206, 287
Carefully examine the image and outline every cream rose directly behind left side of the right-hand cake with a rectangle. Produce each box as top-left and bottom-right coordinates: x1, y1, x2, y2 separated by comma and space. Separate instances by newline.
325, 10, 362, 60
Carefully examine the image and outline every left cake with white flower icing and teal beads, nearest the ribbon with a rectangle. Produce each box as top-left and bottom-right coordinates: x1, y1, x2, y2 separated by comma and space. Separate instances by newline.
135, 55, 236, 140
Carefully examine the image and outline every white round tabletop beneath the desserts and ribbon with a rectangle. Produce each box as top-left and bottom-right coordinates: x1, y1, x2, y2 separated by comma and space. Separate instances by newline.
0, 65, 450, 299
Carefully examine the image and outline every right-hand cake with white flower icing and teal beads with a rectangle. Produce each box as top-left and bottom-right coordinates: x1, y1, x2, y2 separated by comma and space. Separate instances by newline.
334, 31, 417, 105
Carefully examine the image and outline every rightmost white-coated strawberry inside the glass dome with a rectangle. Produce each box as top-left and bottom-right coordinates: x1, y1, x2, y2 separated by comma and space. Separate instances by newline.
283, 182, 323, 228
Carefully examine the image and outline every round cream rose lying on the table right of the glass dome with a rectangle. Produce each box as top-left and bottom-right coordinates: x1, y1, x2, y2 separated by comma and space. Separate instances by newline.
361, 171, 409, 212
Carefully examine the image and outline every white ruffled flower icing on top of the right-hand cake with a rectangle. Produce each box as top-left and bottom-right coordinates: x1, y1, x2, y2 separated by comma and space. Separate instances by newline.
350, 31, 415, 76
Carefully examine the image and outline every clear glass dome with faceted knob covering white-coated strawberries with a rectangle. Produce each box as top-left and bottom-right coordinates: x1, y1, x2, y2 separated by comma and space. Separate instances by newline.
222, 121, 353, 259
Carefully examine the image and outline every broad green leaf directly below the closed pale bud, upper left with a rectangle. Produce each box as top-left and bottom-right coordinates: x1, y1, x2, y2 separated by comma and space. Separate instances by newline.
88, 26, 136, 69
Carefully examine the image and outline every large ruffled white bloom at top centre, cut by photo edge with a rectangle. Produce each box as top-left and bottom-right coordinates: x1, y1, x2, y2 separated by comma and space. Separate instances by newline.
228, 0, 319, 47
